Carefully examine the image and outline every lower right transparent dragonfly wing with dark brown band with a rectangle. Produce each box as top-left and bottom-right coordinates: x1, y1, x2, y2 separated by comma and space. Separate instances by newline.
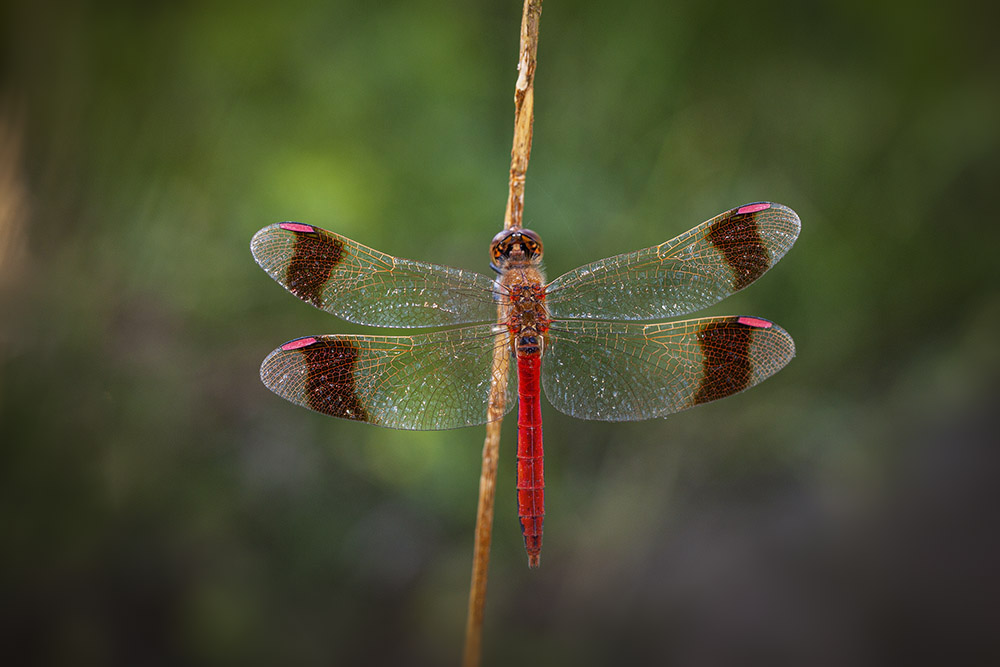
542, 317, 795, 421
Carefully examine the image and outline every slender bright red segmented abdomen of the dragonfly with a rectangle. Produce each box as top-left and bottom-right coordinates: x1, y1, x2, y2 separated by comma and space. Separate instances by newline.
517, 351, 545, 567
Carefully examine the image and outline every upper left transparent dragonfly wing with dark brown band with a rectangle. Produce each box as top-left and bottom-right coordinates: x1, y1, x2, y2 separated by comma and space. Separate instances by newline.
250, 222, 496, 327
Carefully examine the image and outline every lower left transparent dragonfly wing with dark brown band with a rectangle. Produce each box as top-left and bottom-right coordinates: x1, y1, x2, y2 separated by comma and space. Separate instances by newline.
260, 325, 517, 431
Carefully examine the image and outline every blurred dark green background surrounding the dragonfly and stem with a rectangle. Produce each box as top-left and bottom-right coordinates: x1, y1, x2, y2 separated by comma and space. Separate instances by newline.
0, 0, 1000, 665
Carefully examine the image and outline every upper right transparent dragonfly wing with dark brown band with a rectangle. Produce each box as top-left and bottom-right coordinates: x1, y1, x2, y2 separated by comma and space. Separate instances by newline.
546, 202, 800, 320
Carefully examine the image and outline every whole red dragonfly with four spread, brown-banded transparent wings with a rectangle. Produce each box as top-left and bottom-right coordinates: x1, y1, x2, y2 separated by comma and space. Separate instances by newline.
251, 202, 800, 567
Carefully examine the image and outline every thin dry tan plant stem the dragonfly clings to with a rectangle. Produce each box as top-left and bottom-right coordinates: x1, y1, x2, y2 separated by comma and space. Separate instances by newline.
462, 0, 542, 667
